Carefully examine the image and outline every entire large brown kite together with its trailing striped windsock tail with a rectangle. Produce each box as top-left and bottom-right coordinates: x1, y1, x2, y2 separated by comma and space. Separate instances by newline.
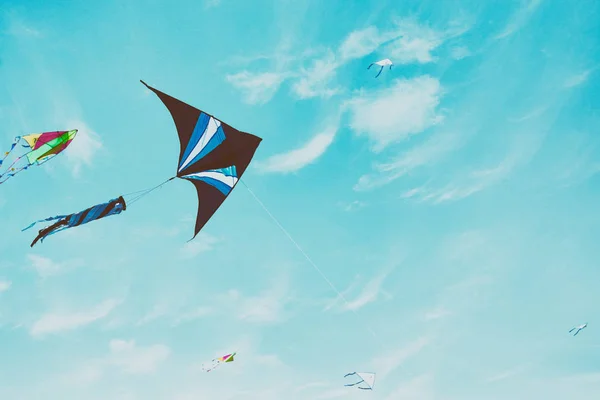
23, 81, 262, 247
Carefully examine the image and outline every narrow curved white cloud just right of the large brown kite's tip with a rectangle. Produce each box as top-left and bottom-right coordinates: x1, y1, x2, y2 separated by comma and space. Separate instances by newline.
259, 126, 337, 173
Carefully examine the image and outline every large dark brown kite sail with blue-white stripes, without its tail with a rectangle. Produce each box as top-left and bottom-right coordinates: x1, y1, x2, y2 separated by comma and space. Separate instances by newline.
141, 81, 262, 239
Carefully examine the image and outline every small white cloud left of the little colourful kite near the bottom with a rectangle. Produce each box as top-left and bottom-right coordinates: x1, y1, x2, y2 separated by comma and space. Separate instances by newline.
106, 339, 171, 375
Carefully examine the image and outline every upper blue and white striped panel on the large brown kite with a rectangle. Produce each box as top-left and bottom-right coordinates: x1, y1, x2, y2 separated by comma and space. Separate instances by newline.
179, 112, 225, 172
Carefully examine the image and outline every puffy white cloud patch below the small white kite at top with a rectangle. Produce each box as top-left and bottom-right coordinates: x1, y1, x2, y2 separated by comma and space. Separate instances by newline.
347, 75, 443, 152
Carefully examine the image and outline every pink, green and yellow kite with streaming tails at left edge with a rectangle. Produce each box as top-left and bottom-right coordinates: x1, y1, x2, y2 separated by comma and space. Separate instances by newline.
0, 129, 77, 184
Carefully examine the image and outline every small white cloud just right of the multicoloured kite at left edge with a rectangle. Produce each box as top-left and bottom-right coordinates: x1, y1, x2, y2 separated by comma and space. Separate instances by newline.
64, 120, 102, 177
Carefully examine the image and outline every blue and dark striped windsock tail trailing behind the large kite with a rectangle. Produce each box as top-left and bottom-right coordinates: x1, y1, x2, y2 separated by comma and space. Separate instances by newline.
23, 196, 127, 247
